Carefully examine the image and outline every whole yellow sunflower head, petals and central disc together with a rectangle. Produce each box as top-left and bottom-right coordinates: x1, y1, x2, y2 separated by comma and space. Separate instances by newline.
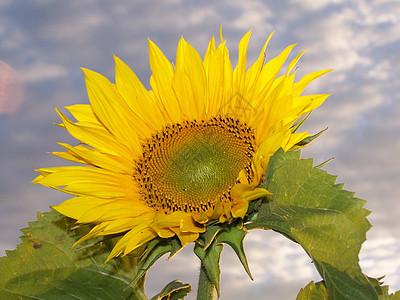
34, 32, 329, 259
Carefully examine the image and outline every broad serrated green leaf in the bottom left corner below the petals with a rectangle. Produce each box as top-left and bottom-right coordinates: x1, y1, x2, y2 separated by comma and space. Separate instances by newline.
0, 211, 147, 300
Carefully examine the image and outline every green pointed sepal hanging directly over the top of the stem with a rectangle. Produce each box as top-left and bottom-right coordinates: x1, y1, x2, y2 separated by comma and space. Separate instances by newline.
194, 239, 223, 298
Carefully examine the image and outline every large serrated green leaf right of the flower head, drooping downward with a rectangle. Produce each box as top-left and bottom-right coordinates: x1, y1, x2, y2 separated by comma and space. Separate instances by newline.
246, 149, 378, 299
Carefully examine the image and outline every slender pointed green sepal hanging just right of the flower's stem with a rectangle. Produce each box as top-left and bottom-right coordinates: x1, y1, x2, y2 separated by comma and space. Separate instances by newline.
216, 226, 253, 280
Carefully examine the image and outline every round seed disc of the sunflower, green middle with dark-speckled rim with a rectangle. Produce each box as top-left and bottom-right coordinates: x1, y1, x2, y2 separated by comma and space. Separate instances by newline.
135, 118, 254, 212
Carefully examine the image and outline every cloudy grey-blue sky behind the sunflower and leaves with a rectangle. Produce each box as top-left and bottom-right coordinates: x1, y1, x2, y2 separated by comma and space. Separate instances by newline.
0, 0, 400, 299
